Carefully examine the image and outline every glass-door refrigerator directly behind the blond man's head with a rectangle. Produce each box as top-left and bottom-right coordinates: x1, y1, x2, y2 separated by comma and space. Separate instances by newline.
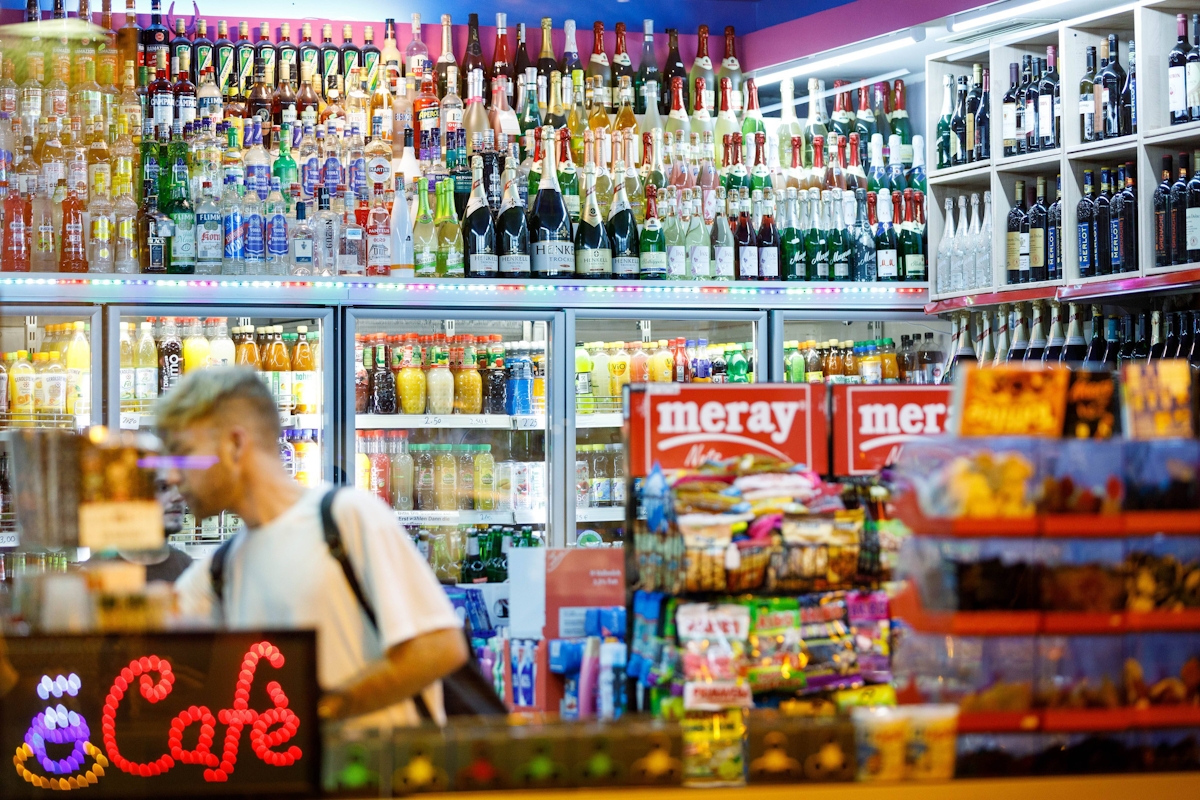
106, 305, 336, 558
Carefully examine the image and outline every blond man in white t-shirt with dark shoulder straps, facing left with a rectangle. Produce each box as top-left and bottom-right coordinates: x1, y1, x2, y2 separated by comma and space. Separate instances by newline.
166, 367, 467, 724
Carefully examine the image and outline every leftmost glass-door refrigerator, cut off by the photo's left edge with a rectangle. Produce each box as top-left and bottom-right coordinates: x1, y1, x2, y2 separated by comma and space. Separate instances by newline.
0, 303, 104, 554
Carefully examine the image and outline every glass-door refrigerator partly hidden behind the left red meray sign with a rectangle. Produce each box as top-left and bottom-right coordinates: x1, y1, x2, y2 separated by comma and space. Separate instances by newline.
565, 309, 767, 546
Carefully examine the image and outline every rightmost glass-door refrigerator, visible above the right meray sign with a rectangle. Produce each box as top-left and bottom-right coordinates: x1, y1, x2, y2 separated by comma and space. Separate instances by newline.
766, 311, 952, 384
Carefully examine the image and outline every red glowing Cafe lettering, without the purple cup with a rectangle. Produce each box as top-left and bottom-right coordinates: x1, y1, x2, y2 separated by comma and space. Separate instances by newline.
101, 642, 302, 782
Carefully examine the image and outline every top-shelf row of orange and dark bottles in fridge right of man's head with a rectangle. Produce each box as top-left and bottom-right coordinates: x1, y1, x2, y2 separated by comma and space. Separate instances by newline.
354, 333, 546, 415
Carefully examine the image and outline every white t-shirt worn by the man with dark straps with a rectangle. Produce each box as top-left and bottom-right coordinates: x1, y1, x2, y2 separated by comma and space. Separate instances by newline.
175, 486, 462, 724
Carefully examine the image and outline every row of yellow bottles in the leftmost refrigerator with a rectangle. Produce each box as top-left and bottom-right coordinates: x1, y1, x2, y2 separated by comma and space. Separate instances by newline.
0, 321, 91, 428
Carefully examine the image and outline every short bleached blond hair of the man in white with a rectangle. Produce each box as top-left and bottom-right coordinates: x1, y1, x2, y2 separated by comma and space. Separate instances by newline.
155, 367, 280, 443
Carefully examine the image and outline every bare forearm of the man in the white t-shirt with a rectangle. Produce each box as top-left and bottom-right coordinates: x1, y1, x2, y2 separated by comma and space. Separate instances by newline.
318, 628, 468, 720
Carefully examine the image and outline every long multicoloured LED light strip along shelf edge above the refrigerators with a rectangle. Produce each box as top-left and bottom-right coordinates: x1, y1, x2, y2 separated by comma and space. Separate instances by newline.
0, 278, 926, 296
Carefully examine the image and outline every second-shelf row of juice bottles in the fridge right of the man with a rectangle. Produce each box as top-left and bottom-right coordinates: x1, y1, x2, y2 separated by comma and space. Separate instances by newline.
354, 431, 547, 511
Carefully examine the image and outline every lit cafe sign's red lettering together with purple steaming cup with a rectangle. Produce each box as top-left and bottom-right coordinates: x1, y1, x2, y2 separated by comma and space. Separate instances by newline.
13, 642, 304, 790
